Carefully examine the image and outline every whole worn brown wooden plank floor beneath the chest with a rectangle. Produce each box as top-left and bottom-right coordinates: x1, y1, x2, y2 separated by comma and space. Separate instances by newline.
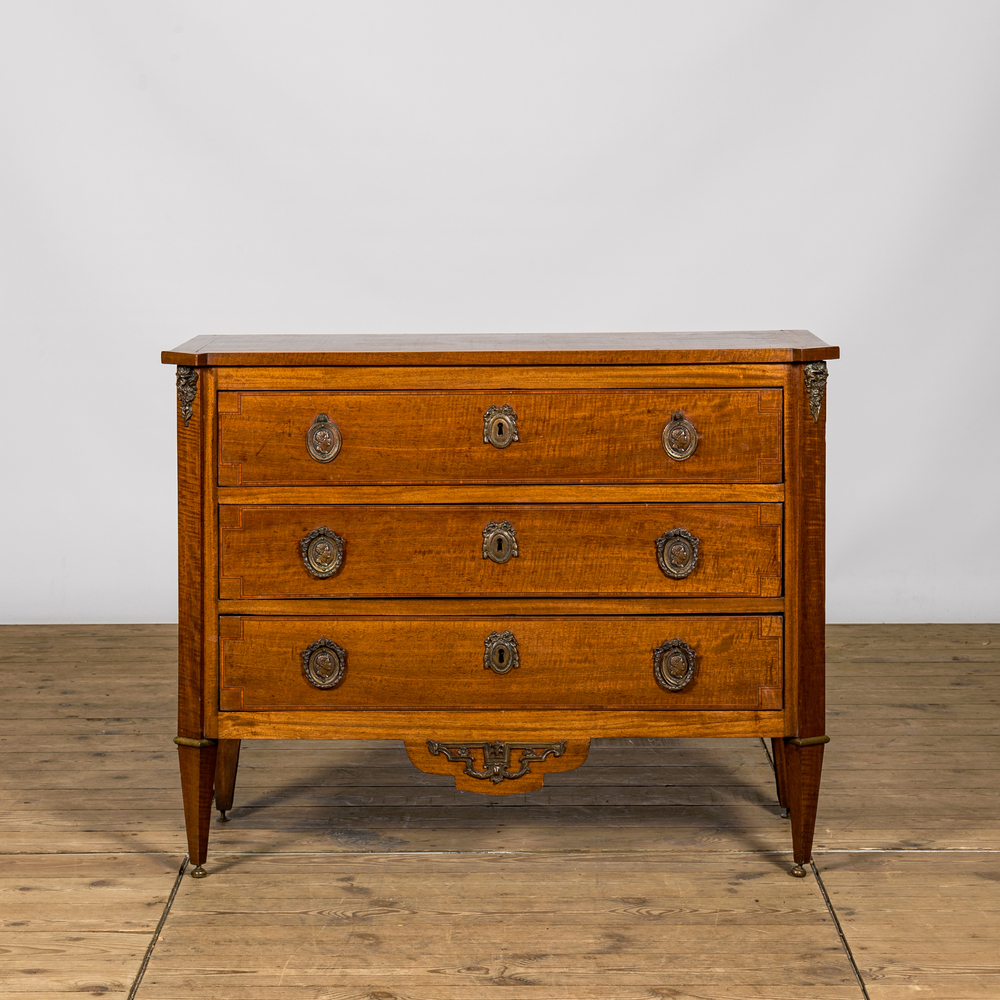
0, 625, 1000, 1000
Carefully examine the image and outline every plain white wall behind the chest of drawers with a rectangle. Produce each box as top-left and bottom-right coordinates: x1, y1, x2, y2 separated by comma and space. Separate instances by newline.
0, 0, 1000, 622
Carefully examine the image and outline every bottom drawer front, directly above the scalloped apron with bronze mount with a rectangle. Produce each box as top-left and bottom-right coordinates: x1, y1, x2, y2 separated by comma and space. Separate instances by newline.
219, 616, 782, 711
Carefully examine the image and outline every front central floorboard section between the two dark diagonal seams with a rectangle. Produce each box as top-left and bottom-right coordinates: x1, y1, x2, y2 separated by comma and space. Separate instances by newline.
140, 854, 857, 1000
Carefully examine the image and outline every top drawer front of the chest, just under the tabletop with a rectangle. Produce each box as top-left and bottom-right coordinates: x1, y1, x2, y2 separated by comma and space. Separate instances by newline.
218, 389, 782, 486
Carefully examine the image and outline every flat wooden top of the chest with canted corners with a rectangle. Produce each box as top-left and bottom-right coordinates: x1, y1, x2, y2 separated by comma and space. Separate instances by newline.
162, 330, 840, 366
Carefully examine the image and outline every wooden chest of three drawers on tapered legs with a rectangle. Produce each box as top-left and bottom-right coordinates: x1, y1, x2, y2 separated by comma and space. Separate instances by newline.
163, 331, 839, 876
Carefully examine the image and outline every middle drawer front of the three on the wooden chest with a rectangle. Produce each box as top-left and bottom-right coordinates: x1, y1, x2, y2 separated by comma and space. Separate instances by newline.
219, 504, 782, 600
